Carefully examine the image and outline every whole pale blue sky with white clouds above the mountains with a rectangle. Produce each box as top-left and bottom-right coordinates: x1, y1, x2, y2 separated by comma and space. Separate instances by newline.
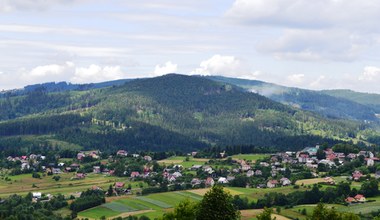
0, 0, 380, 93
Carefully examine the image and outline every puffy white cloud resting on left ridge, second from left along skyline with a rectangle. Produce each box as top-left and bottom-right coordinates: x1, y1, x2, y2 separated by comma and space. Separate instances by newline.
71, 64, 124, 83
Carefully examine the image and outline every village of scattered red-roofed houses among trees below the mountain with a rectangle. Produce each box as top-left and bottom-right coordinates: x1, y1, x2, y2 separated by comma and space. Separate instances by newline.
2, 145, 380, 207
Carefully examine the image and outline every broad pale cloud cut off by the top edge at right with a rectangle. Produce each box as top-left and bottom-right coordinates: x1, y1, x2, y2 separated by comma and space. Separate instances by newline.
226, 0, 380, 31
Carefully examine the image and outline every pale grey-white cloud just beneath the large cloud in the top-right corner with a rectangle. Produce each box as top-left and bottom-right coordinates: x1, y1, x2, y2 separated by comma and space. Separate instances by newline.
257, 29, 371, 61
